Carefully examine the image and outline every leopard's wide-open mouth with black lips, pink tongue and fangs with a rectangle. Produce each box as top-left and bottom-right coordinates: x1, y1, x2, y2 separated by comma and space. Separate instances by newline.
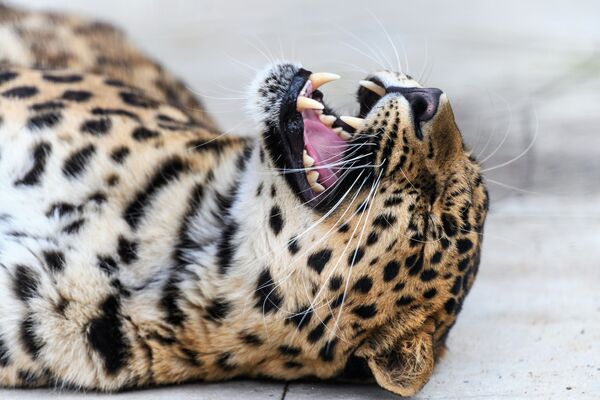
273, 69, 375, 209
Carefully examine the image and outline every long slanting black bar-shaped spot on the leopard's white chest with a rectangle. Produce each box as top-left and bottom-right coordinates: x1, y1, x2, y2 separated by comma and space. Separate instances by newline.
123, 157, 187, 229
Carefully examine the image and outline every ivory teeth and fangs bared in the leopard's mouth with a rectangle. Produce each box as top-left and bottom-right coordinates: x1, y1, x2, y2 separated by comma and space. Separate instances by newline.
296, 72, 385, 193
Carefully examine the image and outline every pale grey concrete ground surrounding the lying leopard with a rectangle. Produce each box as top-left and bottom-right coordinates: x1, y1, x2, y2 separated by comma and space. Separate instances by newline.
0, 0, 600, 400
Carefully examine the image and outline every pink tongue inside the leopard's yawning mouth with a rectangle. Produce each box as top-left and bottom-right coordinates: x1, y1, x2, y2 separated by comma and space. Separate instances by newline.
303, 117, 347, 188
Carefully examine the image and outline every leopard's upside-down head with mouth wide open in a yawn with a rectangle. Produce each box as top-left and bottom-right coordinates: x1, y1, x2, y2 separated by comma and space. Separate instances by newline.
248, 63, 488, 395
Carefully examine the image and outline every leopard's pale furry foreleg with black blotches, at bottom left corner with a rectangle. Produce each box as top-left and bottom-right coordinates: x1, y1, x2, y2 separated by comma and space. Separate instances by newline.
0, 238, 152, 390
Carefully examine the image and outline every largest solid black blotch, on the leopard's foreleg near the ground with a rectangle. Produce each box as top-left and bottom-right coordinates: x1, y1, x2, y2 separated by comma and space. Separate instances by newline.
87, 295, 131, 375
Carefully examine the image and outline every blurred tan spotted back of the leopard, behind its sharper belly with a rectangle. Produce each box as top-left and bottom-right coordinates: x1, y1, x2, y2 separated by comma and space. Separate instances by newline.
0, 4, 216, 130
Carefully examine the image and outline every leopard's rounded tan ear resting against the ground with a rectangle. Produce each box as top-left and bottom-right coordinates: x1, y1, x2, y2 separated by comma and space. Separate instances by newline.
367, 324, 435, 396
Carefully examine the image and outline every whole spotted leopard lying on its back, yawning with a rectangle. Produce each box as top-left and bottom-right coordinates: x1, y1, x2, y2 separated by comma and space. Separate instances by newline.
0, 5, 489, 396
